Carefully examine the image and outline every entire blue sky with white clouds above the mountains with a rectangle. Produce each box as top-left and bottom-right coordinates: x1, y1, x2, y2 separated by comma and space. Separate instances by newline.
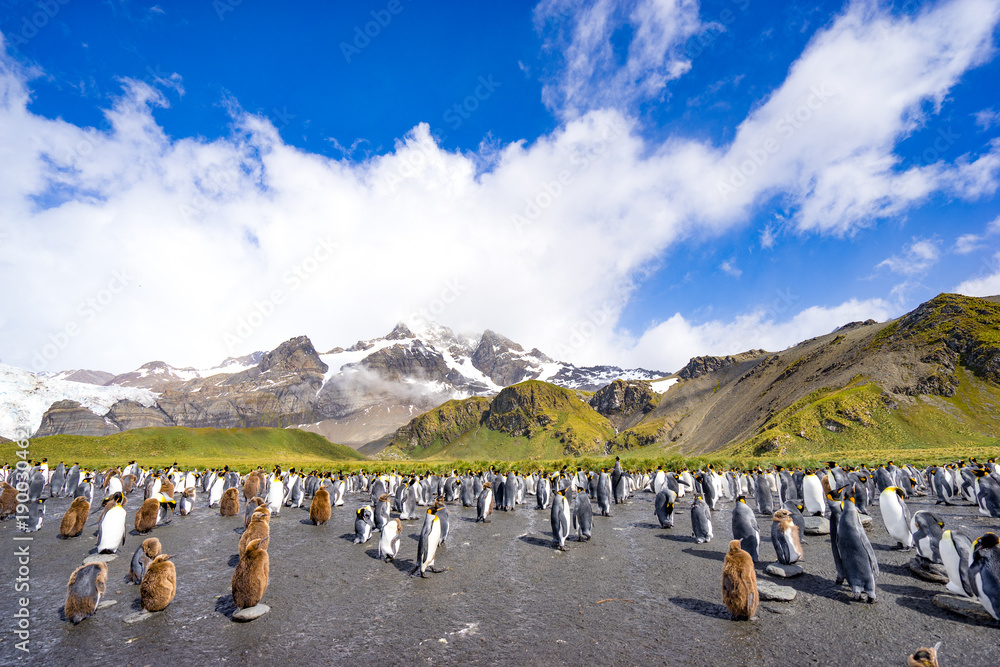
0, 0, 1000, 371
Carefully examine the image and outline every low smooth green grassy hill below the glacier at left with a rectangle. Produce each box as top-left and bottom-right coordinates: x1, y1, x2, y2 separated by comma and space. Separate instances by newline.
0, 426, 364, 469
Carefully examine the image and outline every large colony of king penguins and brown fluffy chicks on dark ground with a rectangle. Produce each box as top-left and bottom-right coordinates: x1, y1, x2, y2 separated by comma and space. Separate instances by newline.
0, 459, 1000, 664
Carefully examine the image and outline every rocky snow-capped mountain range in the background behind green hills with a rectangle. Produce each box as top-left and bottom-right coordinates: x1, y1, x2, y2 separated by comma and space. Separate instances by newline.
7, 322, 667, 446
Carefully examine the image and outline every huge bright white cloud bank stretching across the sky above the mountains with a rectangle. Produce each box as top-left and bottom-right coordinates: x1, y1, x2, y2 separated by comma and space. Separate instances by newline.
0, 0, 1000, 371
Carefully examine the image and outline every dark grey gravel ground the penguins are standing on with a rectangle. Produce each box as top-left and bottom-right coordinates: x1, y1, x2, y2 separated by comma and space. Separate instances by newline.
0, 493, 1000, 667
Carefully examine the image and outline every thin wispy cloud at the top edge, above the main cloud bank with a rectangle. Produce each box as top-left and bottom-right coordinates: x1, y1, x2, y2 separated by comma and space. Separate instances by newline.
535, 0, 705, 119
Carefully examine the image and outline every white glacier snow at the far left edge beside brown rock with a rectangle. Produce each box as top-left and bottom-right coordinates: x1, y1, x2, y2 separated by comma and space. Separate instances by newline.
0, 364, 158, 438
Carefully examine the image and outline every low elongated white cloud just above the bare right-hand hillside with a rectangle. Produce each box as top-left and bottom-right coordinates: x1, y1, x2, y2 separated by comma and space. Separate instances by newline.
630, 294, 898, 371
